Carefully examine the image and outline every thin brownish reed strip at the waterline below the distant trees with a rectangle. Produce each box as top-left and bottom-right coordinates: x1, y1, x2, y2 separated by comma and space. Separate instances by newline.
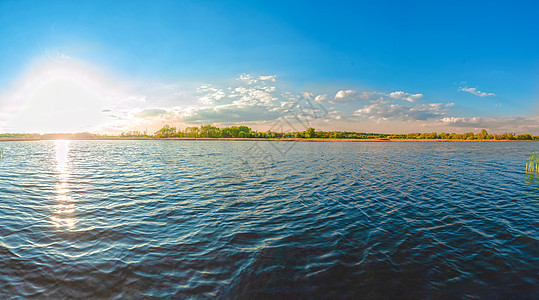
0, 137, 534, 142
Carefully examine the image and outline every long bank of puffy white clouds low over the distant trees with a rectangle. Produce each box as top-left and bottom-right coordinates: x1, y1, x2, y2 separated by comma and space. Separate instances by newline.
102, 74, 452, 133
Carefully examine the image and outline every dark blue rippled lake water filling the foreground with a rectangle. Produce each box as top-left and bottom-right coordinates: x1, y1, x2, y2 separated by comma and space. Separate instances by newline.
0, 141, 539, 299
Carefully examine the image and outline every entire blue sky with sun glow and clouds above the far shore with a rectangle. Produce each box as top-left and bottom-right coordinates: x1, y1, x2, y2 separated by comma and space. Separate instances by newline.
0, 0, 539, 134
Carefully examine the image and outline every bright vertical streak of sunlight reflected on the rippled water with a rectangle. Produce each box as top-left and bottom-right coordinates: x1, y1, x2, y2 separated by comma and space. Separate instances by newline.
51, 140, 76, 228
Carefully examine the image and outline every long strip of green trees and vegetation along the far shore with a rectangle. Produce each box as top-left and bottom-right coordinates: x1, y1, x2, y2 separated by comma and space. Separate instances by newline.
0, 125, 539, 142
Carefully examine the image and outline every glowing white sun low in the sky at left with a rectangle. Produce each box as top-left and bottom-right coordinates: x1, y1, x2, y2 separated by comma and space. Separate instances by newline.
3, 61, 114, 133
